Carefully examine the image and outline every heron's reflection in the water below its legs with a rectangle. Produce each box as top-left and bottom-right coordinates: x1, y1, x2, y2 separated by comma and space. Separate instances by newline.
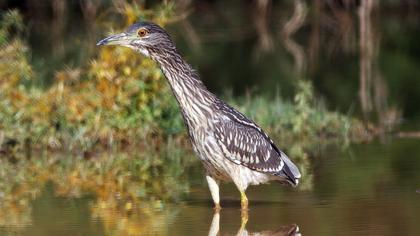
209, 211, 301, 236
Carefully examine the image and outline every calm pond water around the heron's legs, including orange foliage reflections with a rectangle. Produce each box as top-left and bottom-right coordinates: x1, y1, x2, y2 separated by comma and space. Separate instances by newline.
0, 139, 420, 236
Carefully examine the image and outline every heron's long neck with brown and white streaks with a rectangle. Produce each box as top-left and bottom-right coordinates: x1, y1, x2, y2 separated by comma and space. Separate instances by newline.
151, 48, 216, 125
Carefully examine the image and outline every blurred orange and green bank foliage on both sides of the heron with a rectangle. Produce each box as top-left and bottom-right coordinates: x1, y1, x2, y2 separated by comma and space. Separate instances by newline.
0, 4, 368, 155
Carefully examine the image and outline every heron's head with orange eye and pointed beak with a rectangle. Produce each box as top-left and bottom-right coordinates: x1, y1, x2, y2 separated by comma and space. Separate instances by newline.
96, 22, 175, 57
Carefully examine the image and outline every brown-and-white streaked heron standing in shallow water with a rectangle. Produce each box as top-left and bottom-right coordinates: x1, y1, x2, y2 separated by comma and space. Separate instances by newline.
97, 21, 301, 210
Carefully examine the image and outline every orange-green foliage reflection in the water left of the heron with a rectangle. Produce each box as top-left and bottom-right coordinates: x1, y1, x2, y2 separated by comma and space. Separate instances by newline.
0, 146, 193, 235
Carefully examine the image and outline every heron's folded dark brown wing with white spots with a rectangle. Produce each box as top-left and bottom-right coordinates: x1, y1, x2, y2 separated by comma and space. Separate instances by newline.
214, 102, 300, 176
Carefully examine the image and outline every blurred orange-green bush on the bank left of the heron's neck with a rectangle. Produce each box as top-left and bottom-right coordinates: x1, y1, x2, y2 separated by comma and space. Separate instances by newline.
0, 2, 183, 150
